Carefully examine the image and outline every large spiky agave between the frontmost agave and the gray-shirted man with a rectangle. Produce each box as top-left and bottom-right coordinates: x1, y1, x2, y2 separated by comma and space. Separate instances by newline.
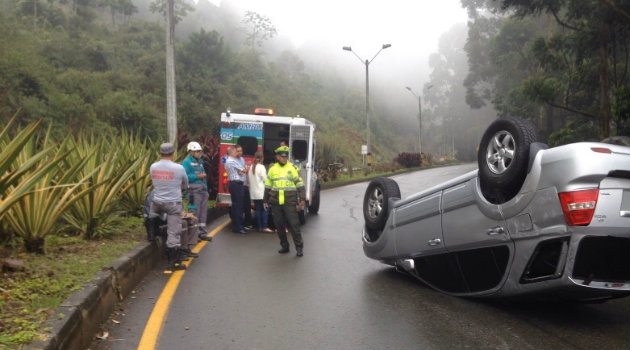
64, 135, 143, 239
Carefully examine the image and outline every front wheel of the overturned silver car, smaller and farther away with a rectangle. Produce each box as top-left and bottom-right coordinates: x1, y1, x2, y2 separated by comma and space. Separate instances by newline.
363, 177, 400, 235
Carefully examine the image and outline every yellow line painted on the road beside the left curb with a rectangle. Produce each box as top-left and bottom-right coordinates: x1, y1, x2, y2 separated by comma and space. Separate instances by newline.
138, 219, 230, 350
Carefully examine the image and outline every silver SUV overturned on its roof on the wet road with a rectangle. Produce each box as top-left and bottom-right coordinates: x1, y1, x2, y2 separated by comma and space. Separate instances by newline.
363, 118, 630, 301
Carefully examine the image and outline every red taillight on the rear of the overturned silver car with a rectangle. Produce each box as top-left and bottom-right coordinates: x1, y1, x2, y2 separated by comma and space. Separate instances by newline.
558, 189, 599, 226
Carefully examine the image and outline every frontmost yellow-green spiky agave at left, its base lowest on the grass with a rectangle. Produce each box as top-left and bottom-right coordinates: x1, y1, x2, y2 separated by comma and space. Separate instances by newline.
5, 129, 99, 253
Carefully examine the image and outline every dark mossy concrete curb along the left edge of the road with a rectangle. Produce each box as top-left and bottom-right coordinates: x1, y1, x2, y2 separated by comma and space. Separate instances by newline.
23, 207, 228, 350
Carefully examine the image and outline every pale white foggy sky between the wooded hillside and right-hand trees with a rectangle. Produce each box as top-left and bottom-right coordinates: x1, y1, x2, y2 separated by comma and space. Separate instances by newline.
195, 0, 482, 154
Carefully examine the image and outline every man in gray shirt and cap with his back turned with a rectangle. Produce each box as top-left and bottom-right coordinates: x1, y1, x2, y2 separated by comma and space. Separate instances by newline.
150, 143, 188, 273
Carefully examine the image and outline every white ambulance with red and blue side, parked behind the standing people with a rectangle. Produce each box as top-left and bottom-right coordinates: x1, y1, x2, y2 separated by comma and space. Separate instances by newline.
216, 108, 320, 224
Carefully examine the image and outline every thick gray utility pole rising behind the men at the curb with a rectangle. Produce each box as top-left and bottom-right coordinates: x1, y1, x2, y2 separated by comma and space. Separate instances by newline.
166, 0, 177, 142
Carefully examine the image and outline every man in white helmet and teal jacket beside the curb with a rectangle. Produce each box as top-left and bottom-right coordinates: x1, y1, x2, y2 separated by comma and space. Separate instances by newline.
182, 141, 212, 245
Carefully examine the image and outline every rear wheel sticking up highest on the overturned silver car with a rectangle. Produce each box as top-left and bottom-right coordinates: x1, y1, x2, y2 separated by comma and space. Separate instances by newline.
477, 117, 538, 204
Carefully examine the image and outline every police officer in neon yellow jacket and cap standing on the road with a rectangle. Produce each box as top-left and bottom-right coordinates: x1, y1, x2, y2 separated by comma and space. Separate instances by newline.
263, 146, 306, 256
